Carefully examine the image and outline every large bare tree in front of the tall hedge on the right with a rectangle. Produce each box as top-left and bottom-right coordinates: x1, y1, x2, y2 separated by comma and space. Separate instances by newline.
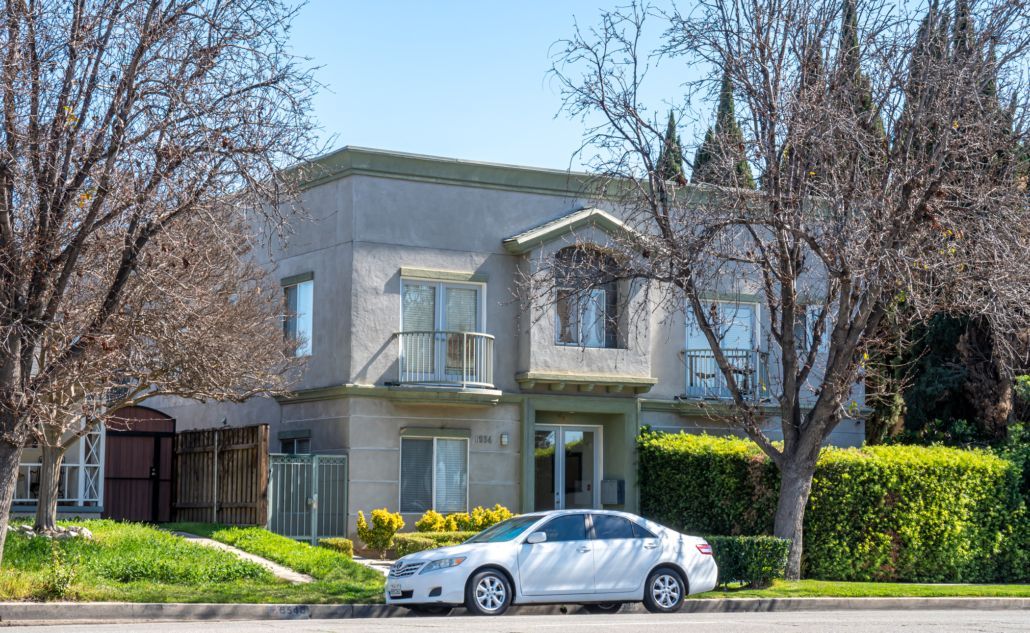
552, 0, 1030, 578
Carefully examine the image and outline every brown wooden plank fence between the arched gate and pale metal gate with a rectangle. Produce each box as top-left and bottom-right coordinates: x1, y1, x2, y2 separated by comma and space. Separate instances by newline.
174, 424, 268, 525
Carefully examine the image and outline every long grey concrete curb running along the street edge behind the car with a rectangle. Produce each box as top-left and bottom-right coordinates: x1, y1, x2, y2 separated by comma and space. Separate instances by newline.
0, 598, 1030, 625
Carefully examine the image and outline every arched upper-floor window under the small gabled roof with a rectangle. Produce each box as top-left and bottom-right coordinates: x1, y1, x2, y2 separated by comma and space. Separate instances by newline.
554, 246, 619, 348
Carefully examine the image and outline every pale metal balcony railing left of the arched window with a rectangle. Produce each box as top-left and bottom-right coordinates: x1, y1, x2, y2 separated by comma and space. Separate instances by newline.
397, 330, 493, 389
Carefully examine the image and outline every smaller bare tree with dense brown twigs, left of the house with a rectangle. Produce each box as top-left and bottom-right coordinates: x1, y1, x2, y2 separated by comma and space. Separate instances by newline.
32, 206, 299, 533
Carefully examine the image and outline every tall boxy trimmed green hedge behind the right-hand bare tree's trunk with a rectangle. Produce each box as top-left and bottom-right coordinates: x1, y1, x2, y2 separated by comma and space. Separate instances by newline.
638, 432, 1030, 583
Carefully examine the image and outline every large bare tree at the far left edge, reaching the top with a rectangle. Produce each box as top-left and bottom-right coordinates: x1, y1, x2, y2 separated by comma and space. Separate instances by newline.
0, 0, 314, 564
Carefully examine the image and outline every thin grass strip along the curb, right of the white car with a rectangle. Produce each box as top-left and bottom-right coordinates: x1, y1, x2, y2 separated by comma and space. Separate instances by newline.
690, 581, 1030, 599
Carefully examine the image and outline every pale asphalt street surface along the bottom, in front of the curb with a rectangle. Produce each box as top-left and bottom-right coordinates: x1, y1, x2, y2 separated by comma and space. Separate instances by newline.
10, 610, 1030, 633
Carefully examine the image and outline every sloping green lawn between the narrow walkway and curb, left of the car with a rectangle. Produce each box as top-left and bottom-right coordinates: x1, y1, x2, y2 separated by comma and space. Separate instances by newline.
0, 520, 383, 603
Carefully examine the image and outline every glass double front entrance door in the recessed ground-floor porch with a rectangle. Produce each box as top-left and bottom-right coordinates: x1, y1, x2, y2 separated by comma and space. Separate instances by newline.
534, 424, 602, 511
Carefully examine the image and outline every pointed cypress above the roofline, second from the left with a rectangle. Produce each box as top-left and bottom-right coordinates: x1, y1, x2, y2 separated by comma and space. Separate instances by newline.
691, 72, 755, 189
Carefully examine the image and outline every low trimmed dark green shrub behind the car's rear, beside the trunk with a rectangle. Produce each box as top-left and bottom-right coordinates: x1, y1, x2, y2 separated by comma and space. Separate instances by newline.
706, 536, 790, 587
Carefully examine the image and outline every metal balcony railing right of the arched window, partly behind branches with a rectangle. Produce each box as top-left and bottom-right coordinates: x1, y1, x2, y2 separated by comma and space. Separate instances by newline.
685, 349, 768, 400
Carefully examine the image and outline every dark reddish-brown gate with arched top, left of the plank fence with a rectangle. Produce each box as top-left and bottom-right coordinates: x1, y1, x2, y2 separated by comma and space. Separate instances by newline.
102, 407, 175, 523
